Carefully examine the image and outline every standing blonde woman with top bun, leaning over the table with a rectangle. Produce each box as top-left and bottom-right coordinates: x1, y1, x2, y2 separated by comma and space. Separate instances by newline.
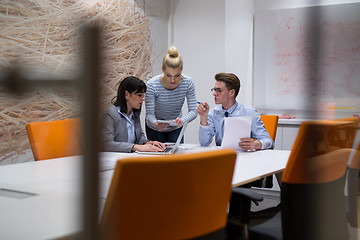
145, 46, 197, 143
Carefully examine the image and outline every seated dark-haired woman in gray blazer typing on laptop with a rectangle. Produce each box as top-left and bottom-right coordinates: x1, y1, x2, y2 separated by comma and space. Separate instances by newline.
102, 76, 165, 152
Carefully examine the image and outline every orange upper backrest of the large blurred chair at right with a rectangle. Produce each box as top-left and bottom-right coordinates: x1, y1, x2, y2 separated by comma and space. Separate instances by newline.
282, 118, 360, 183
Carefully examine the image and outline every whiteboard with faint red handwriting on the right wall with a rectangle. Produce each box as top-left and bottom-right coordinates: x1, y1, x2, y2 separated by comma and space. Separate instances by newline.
253, 3, 360, 111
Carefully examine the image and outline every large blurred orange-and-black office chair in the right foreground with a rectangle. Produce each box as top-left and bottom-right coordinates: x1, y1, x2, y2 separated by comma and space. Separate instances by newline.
233, 118, 359, 240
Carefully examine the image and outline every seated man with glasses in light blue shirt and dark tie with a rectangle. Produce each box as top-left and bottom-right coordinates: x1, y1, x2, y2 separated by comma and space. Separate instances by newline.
196, 73, 274, 151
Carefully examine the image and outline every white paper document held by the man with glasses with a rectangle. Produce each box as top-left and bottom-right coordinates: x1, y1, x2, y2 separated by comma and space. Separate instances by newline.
221, 116, 252, 151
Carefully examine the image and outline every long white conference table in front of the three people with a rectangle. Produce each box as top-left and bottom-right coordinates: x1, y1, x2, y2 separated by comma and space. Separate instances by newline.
0, 144, 290, 239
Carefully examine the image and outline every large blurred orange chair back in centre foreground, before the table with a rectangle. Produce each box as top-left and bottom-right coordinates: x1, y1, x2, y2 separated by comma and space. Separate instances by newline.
100, 149, 236, 240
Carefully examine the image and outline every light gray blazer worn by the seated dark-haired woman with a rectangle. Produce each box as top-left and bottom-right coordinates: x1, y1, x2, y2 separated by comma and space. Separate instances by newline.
101, 105, 149, 152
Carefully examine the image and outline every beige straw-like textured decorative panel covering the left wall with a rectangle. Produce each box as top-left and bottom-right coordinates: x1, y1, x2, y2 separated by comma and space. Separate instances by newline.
0, 0, 151, 163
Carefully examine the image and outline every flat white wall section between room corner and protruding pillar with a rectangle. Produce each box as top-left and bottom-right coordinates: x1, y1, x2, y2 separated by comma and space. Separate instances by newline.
173, 0, 225, 143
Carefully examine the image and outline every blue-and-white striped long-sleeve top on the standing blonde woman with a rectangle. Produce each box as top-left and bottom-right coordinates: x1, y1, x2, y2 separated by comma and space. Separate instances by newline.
145, 74, 197, 132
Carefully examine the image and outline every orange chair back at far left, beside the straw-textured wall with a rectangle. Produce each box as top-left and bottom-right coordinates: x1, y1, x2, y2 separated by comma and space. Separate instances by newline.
25, 119, 81, 161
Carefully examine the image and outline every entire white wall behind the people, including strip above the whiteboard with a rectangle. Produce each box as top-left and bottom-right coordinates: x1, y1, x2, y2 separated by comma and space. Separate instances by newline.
143, 0, 360, 143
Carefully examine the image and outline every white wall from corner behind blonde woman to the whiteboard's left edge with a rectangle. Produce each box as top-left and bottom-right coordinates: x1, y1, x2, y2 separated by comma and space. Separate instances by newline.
172, 0, 253, 143
